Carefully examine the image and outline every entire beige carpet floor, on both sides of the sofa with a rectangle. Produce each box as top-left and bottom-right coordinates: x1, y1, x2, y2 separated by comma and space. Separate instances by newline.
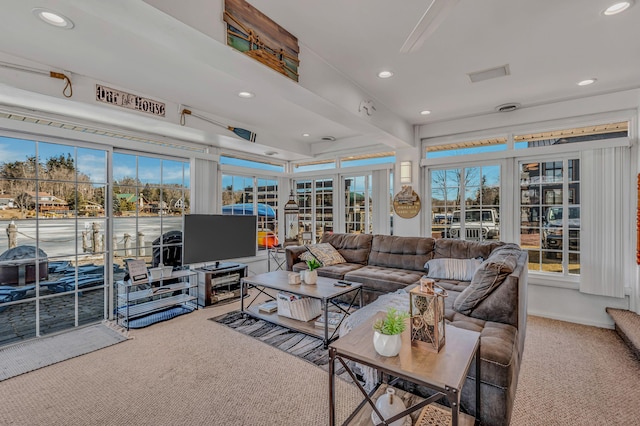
0, 298, 640, 426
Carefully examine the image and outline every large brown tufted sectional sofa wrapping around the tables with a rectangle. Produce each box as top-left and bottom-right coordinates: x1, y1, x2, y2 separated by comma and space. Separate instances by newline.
286, 233, 527, 426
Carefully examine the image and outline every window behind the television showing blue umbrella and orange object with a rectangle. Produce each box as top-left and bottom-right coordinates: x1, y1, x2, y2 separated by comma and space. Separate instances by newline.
222, 174, 279, 250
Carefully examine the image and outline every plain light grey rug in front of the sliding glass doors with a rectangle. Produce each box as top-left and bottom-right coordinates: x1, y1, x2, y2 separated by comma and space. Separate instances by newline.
0, 323, 127, 381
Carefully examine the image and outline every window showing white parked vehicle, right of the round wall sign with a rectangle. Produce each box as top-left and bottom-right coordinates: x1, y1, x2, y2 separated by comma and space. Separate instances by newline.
430, 165, 500, 241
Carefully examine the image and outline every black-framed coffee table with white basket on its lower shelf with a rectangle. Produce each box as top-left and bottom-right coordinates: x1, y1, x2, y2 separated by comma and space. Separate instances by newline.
240, 271, 363, 348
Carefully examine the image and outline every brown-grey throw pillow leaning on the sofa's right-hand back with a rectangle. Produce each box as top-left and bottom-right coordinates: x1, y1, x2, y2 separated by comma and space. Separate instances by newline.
453, 248, 519, 315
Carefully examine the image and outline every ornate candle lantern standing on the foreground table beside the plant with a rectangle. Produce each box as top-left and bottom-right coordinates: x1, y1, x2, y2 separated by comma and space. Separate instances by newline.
409, 277, 447, 352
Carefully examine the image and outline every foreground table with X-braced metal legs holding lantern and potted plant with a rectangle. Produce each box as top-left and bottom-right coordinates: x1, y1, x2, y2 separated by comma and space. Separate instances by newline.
329, 313, 480, 426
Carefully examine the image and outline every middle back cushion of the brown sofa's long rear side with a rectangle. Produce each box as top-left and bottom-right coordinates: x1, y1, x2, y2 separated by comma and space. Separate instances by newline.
368, 235, 435, 271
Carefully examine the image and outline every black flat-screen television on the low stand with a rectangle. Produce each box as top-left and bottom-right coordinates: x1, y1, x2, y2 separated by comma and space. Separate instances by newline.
182, 214, 258, 265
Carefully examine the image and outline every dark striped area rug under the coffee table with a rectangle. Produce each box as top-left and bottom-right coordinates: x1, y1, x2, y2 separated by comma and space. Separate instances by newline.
209, 311, 350, 380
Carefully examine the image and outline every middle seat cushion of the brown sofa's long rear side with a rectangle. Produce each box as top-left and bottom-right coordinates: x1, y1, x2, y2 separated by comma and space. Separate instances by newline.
344, 265, 422, 293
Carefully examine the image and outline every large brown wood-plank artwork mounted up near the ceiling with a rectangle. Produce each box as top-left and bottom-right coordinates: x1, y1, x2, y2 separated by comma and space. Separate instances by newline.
224, 0, 300, 81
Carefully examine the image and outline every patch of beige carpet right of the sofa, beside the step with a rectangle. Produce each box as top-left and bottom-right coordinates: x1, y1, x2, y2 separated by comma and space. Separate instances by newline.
511, 317, 640, 426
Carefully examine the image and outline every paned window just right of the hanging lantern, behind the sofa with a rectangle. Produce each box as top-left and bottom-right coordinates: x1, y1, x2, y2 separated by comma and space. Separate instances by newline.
296, 179, 333, 243
